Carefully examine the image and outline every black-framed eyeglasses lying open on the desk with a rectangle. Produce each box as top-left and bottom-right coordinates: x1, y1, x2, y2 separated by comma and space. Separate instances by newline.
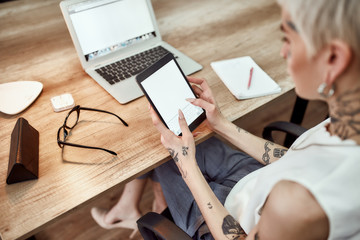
57, 105, 129, 156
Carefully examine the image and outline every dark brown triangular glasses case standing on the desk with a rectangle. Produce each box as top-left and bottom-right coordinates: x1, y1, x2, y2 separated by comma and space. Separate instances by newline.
6, 118, 39, 184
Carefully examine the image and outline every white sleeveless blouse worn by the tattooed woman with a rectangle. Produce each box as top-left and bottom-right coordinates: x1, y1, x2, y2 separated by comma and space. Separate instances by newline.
225, 119, 360, 239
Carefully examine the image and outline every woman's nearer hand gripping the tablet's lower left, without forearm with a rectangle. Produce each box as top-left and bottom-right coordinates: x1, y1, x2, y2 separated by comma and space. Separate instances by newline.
150, 107, 197, 178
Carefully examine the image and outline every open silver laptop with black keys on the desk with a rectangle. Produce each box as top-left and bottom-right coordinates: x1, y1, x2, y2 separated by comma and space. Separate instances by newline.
60, 0, 202, 104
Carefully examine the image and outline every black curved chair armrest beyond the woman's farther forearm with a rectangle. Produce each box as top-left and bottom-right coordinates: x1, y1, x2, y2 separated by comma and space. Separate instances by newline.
262, 121, 307, 141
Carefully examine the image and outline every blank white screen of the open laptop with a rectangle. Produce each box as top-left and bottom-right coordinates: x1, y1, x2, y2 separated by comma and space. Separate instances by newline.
68, 0, 156, 61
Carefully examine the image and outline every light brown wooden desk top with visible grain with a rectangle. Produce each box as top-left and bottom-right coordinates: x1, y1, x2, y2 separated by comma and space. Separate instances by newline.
0, 0, 293, 239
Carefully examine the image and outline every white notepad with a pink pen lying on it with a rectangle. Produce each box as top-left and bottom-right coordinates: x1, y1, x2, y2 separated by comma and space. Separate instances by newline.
211, 56, 281, 99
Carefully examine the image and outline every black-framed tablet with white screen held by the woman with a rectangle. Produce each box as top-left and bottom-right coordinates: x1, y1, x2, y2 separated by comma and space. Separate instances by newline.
136, 54, 206, 136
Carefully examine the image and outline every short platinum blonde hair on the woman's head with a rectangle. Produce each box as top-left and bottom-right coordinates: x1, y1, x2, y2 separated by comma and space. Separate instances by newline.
277, 0, 360, 58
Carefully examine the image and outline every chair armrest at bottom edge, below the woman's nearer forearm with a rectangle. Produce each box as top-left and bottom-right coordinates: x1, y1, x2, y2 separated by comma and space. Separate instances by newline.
137, 212, 192, 240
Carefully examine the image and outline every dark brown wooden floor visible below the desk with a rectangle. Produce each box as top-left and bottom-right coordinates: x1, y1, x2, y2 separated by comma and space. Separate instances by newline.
35, 92, 327, 240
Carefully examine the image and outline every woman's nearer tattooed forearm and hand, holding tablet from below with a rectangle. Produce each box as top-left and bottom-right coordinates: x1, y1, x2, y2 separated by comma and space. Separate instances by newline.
151, 109, 244, 240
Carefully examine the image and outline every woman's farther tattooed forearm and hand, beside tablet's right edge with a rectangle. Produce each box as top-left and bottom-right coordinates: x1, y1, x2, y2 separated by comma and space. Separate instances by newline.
188, 77, 287, 164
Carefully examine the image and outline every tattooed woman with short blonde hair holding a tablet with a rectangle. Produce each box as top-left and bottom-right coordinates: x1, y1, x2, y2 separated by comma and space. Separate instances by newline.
150, 0, 360, 240
